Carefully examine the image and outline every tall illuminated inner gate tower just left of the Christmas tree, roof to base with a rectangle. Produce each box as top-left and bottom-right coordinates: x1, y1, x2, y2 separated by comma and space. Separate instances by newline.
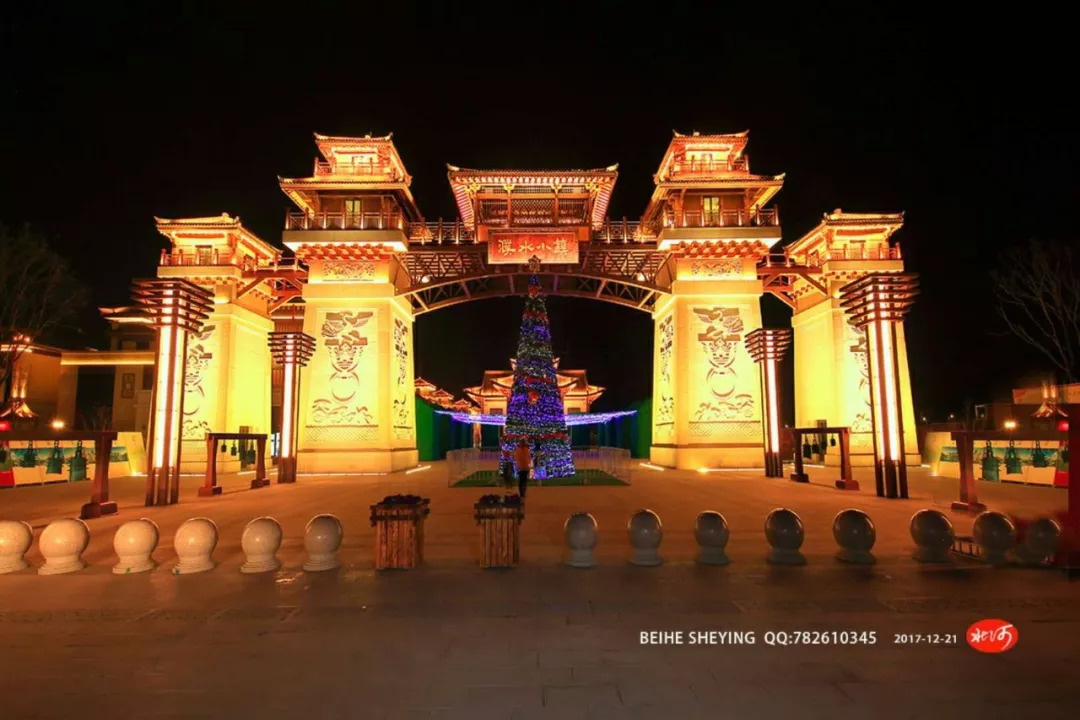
280, 135, 420, 474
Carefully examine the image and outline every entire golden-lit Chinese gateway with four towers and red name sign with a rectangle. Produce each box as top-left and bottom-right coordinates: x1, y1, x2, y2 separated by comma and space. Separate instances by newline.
110, 133, 917, 490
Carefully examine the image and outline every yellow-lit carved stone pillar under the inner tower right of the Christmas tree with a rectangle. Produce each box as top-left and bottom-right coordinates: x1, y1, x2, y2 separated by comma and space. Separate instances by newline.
649, 257, 764, 470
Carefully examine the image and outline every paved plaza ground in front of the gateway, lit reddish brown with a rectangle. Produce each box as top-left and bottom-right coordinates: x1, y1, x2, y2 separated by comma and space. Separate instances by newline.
0, 463, 1080, 719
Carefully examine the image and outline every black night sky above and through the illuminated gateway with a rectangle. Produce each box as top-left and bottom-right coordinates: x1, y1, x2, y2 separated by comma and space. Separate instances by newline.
0, 2, 1078, 417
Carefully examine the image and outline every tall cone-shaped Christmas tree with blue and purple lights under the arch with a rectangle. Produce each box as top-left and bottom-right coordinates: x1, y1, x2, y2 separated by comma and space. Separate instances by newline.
502, 258, 573, 477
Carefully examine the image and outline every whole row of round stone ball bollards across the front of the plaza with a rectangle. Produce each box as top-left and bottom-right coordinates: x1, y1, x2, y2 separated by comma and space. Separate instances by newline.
0, 507, 1063, 575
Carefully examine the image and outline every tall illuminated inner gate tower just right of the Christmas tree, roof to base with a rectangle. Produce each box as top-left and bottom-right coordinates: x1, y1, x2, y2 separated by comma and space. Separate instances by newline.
642, 133, 784, 470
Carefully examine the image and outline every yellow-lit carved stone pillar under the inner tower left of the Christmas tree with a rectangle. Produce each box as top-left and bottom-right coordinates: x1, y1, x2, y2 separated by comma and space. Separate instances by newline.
297, 258, 418, 474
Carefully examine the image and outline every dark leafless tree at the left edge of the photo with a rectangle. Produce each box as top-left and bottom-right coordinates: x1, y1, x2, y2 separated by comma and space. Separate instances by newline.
0, 225, 86, 402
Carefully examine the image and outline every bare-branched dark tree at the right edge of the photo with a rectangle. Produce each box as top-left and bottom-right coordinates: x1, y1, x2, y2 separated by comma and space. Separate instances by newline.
990, 241, 1080, 382
